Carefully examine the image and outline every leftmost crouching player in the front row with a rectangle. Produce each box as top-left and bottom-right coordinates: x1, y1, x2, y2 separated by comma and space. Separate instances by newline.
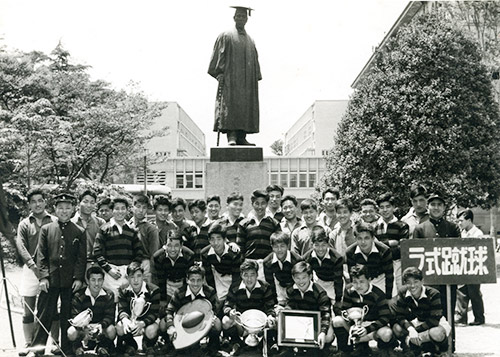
68, 265, 116, 356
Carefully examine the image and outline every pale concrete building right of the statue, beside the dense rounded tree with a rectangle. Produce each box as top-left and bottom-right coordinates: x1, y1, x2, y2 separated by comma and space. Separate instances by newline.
283, 100, 349, 157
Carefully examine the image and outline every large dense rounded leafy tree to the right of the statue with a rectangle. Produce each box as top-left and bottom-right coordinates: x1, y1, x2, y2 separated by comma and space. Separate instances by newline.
323, 15, 500, 208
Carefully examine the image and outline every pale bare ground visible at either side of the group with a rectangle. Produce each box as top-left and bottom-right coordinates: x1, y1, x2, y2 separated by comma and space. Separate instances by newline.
0, 253, 500, 357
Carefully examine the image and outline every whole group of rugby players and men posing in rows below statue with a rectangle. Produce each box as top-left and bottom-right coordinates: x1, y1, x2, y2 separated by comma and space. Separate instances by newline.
17, 185, 484, 356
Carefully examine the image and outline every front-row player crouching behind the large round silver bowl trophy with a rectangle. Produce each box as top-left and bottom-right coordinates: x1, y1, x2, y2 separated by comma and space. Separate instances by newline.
222, 259, 276, 356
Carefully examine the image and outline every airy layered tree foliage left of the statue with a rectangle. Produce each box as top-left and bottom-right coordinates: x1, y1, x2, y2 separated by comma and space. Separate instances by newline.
0, 44, 161, 188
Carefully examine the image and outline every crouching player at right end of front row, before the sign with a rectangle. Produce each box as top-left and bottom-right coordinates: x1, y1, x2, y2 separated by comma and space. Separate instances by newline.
393, 267, 451, 353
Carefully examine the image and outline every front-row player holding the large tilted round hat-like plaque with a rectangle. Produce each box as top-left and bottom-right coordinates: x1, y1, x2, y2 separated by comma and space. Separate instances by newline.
165, 265, 222, 355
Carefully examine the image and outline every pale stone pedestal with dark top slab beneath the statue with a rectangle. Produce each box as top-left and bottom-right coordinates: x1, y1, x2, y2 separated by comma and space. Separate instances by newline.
205, 146, 269, 214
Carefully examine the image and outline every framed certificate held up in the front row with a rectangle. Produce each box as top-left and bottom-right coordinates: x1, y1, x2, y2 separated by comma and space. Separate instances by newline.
278, 310, 321, 348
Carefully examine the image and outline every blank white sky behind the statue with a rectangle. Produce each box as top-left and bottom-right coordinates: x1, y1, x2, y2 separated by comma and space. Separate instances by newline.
0, 0, 408, 155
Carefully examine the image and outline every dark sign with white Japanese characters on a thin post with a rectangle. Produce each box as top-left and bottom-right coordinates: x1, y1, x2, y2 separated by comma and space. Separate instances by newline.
401, 238, 497, 352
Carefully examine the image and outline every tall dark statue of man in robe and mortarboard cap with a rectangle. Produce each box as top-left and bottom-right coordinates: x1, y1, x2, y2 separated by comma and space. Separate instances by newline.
208, 7, 262, 145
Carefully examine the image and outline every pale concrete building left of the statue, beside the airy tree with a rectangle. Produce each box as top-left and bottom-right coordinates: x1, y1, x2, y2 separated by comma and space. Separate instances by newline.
146, 102, 206, 160
